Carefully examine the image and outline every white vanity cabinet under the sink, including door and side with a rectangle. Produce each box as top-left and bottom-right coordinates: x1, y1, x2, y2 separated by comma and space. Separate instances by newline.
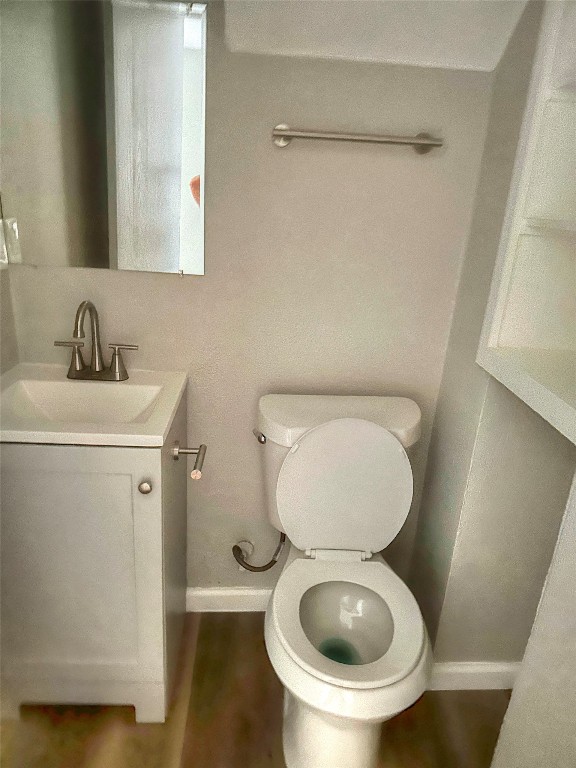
1, 392, 186, 722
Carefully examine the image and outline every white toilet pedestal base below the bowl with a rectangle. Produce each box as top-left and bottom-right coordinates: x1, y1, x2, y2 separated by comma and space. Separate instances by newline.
282, 688, 382, 768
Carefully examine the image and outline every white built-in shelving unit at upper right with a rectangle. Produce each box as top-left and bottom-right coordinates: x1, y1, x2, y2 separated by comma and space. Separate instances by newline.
477, 1, 576, 443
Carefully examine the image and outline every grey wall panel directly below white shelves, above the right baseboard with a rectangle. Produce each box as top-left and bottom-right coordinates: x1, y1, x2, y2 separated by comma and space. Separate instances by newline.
434, 380, 576, 661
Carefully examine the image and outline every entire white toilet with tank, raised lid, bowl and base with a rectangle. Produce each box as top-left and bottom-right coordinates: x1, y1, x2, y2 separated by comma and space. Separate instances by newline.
257, 395, 432, 768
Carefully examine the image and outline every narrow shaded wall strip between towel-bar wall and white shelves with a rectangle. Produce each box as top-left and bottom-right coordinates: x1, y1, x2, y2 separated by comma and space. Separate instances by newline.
411, 4, 540, 636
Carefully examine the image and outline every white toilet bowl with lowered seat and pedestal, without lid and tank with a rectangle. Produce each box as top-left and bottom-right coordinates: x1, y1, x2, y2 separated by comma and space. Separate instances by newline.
265, 553, 432, 768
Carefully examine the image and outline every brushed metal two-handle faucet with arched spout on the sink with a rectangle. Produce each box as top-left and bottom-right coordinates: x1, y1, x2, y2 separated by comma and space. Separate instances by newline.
54, 301, 138, 381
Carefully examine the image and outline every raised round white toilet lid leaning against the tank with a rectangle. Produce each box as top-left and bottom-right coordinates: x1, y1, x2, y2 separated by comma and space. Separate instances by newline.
276, 419, 413, 552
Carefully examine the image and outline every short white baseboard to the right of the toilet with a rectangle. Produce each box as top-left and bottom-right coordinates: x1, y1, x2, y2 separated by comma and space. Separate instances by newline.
428, 661, 520, 691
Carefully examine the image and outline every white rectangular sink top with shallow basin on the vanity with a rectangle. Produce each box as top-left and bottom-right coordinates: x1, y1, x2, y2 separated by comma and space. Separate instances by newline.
0, 363, 186, 446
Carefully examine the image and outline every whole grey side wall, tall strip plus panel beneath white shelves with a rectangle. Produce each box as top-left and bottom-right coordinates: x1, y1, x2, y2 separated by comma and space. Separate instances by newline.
411, 5, 576, 661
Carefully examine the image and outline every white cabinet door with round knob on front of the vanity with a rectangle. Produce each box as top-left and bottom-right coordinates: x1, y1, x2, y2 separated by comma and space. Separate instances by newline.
1, 444, 164, 681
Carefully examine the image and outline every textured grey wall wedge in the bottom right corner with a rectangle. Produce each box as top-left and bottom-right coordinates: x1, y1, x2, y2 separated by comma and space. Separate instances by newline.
492, 477, 576, 768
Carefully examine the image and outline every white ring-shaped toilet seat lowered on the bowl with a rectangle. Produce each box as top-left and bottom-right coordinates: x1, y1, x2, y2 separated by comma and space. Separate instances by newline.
267, 558, 426, 689
